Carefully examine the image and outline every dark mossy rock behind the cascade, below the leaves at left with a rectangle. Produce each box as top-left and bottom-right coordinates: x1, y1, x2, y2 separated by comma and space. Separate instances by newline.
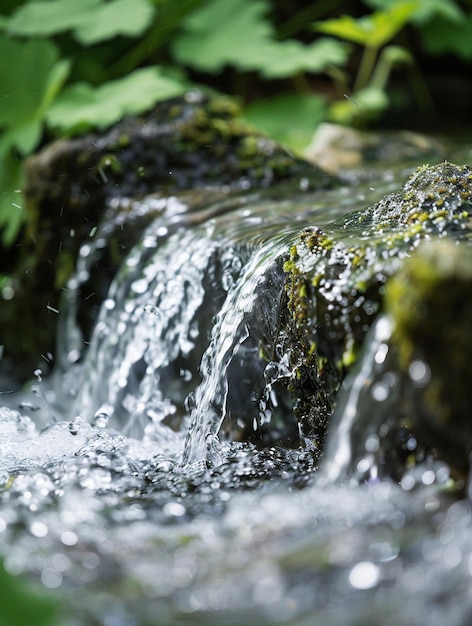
0, 93, 322, 380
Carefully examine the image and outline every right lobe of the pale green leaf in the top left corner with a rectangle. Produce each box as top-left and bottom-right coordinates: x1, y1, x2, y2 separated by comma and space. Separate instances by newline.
74, 0, 154, 45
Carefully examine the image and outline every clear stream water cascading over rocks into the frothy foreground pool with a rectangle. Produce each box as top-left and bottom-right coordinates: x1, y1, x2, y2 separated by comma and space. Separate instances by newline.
0, 152, 472, 626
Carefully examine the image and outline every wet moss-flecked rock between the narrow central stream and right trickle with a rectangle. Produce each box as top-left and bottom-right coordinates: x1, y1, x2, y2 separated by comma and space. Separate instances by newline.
280, 163, 472, 458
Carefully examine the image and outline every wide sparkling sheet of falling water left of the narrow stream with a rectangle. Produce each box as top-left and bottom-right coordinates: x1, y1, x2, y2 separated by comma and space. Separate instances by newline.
74, 229, 219, 436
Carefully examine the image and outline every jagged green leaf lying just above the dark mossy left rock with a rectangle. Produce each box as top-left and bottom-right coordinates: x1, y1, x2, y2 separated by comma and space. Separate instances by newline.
46, 68, 186, 131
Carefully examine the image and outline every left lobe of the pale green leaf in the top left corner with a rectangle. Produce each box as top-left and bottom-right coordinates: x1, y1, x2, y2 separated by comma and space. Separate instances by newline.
8, 0, 102, 37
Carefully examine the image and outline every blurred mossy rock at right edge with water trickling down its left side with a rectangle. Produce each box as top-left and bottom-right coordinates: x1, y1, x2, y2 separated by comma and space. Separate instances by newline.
322, 238, 472, 484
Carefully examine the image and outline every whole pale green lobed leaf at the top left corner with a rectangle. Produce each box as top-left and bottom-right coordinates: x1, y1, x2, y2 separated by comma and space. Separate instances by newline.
7, 0, 154, 45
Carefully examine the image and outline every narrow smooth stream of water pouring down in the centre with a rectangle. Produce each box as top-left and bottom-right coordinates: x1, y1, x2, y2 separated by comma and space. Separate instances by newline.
183, 239, 283, 468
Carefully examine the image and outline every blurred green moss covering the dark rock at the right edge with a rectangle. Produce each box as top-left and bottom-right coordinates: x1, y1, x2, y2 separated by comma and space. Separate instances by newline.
385, 238, 472, 472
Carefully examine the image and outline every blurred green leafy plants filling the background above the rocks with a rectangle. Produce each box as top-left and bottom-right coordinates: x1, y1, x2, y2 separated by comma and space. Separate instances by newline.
0, 0, 472, 245
